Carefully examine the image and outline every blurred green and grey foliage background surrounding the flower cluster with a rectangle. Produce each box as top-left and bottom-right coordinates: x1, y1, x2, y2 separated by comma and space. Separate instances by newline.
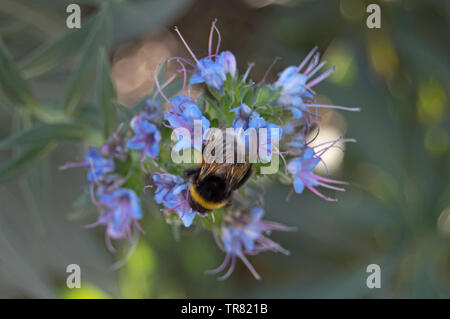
0, 0, 450, 298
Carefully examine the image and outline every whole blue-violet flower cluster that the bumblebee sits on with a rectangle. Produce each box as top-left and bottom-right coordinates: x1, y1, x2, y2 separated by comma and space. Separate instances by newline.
64, 21, 358, 279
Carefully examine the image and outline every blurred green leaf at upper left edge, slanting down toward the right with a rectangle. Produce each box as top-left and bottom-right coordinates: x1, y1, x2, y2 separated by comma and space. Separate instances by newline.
0, 38, 36, 106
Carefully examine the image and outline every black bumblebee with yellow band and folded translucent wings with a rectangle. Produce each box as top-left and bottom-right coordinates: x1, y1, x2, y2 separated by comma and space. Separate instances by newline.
184, 130, 252, 213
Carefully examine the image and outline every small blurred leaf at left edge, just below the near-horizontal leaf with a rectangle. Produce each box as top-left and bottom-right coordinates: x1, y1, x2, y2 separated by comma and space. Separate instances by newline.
0, 143, 57, 184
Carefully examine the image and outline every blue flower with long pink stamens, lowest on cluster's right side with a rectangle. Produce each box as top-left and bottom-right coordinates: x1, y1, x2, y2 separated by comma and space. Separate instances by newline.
287, 148, 347, 201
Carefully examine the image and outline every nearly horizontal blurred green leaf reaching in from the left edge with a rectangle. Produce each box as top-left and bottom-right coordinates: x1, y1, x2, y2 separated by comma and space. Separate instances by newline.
0, 123, 95, 149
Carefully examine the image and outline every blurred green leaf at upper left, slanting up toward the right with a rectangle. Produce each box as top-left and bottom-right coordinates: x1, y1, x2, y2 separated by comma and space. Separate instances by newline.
20, 17, 94, 78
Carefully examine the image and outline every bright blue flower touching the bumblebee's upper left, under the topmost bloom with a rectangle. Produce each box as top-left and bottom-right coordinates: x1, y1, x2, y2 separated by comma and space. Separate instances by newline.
164, 95, 210, 152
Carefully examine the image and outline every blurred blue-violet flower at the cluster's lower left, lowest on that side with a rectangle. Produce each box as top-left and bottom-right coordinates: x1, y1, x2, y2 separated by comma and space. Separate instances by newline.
98, 188, 142, 239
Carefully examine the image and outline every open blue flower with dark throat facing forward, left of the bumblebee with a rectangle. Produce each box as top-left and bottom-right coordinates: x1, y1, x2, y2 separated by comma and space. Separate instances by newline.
127, 114, 161, 158
